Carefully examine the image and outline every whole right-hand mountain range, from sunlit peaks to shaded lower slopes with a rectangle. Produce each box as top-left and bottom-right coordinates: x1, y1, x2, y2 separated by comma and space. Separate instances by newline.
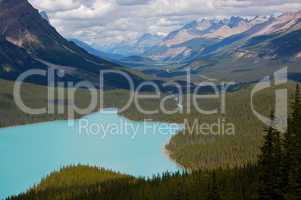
91, 11, 301, 82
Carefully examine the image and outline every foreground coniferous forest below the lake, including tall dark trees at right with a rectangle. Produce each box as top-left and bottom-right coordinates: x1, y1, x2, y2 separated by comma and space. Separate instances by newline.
9, 85, 301, 200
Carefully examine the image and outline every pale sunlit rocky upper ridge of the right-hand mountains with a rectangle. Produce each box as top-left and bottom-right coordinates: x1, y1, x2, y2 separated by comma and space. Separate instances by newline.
144, 12, 301, 61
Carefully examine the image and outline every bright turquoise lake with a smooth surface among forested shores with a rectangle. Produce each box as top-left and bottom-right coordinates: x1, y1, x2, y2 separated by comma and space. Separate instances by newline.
0, 109, 183, 199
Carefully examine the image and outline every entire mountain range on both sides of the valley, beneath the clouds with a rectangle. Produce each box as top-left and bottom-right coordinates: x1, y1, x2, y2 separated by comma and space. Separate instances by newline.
0, 0, 301, 84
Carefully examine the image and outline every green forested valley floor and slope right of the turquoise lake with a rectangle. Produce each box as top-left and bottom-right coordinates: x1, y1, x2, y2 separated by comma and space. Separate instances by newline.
122, 83, 294, 169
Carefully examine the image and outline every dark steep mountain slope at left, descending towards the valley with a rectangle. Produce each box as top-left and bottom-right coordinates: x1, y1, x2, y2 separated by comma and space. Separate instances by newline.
0, 0, 118, 71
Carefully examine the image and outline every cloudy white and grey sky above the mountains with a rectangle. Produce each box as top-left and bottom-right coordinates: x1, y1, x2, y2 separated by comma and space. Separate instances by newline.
29, 0, 301, 47
